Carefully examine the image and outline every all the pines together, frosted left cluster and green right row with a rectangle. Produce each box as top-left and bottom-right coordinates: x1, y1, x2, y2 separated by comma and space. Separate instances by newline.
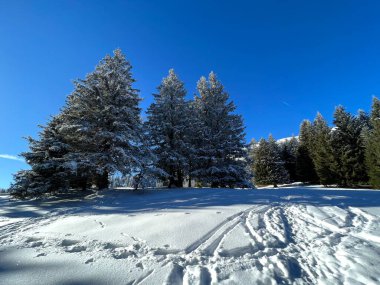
10, 49, 380, 198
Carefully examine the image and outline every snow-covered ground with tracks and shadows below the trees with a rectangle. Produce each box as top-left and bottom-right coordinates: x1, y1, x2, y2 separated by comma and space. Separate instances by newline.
0, 187, 380, 284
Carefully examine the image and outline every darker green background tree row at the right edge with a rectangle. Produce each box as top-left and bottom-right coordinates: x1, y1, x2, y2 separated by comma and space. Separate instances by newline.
250, 97, 380, 189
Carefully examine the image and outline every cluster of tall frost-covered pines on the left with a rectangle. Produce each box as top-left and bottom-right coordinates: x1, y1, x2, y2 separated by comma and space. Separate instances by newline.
10, 49, 251, 198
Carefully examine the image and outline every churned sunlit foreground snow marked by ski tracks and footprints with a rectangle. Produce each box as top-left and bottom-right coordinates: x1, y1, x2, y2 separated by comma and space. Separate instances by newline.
0, 199, 380, 285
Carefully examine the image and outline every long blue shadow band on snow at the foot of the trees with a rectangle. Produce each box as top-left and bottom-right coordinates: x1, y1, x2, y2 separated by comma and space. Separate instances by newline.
0, 187, 380, 218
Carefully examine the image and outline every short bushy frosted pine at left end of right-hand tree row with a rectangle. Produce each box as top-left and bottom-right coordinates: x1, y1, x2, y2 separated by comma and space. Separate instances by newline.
252, 135, 289, 187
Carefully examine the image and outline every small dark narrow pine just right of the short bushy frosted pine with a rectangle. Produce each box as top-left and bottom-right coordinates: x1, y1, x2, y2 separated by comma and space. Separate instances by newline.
280, 137, 299, 182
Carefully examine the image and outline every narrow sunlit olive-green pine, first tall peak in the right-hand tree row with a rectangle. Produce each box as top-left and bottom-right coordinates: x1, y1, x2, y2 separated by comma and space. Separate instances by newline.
312, 113, 337, 186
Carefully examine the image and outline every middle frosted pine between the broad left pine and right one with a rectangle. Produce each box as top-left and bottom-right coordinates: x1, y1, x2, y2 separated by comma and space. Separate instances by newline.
146, 69, 191, 187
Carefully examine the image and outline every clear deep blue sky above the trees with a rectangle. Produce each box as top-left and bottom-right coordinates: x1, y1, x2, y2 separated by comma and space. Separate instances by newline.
0, 0, 380, 187
